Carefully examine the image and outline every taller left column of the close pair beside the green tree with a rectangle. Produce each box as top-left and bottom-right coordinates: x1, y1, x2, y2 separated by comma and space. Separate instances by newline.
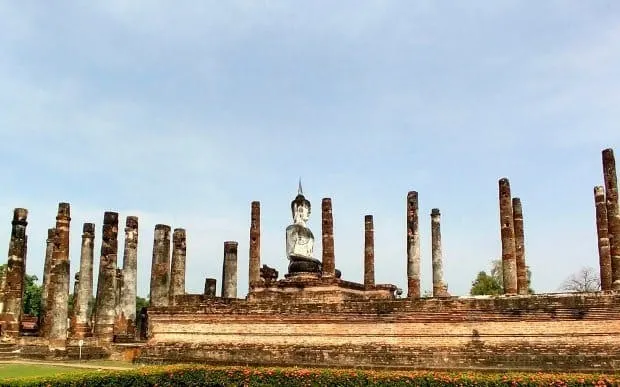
499, 177, 517, 294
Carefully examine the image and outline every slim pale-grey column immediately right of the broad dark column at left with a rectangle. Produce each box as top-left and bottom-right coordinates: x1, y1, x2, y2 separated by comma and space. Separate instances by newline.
120, 216, 138, 334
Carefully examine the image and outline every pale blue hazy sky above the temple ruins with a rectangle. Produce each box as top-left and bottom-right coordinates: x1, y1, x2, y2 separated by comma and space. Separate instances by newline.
0, 0, 620, 296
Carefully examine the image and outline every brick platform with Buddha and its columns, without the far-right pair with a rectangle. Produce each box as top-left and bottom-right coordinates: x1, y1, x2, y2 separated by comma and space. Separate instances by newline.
138, 174, 620, 371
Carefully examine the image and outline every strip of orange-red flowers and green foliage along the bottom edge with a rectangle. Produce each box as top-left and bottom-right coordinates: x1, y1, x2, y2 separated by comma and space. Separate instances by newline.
0, 365, 620, 387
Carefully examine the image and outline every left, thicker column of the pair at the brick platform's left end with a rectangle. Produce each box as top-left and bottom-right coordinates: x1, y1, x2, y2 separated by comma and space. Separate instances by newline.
149, 224, 170, 307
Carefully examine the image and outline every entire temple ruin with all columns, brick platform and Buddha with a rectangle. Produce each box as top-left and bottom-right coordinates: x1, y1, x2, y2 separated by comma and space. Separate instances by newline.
0, 149, 620, 372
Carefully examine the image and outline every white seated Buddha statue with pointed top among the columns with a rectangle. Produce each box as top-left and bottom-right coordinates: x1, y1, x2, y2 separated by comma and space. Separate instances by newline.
286, 182, 321, 274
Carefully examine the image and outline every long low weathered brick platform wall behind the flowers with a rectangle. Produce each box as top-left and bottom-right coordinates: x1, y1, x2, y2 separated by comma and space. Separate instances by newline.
139, 293, 620, 371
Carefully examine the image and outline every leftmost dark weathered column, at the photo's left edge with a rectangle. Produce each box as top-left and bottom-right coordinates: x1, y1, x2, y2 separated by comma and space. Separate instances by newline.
3, 208, 28, 338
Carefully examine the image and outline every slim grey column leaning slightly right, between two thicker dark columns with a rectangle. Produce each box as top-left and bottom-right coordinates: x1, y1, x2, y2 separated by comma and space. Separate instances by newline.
72, 223, 95, 338
